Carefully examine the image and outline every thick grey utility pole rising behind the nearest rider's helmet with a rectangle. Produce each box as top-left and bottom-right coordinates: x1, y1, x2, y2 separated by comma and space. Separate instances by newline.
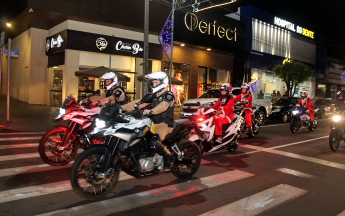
142, 0, 150, 96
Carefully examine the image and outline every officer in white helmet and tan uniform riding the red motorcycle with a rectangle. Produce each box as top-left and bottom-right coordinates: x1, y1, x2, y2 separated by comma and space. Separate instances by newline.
90, 72, 126, 105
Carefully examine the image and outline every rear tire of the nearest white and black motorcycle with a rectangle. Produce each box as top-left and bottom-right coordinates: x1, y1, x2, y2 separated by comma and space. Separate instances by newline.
172, 140, 201, 179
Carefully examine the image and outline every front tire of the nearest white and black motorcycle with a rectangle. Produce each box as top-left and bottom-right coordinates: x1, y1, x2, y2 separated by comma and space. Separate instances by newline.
70, 146, 120, 200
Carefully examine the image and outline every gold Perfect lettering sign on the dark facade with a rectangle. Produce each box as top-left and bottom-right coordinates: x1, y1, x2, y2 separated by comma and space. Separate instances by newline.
184, 12, 237, 41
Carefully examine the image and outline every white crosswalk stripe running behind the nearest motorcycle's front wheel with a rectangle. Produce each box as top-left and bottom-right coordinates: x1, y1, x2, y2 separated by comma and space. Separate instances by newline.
0, 172, 134, 203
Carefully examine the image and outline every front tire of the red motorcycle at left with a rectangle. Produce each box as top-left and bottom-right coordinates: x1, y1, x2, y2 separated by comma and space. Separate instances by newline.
38, 128, 78, 166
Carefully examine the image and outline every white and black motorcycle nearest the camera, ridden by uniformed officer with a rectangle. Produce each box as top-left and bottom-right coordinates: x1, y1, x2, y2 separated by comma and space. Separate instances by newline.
71, 95, 201, 199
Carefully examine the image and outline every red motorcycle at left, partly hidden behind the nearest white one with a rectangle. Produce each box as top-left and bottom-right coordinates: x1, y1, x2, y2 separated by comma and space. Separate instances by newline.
38, 95, 104, 166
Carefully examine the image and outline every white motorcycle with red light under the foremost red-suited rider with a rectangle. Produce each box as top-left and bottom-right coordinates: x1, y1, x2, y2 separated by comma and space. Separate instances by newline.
187, 103, 241, 154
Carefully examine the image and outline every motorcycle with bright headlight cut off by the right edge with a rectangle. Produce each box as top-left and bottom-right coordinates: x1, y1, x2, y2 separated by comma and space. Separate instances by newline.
328, 113, 345, 151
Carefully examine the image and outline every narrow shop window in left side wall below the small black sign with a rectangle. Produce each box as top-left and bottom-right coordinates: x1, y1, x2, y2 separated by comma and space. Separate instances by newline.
50, 69, 63, 106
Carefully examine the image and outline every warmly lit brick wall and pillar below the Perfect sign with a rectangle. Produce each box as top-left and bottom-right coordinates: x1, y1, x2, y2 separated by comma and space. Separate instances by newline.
162, 46, 233, 99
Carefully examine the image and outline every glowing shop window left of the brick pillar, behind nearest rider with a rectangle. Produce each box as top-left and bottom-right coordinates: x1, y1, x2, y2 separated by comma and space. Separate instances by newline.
164, 62, 190, 105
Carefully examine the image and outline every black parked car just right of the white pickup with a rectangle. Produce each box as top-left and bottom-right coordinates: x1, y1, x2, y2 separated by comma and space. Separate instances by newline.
268, 97, 300, 123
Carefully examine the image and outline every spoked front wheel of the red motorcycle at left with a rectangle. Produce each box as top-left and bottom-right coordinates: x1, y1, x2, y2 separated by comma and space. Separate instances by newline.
38, 128, 78, 166
